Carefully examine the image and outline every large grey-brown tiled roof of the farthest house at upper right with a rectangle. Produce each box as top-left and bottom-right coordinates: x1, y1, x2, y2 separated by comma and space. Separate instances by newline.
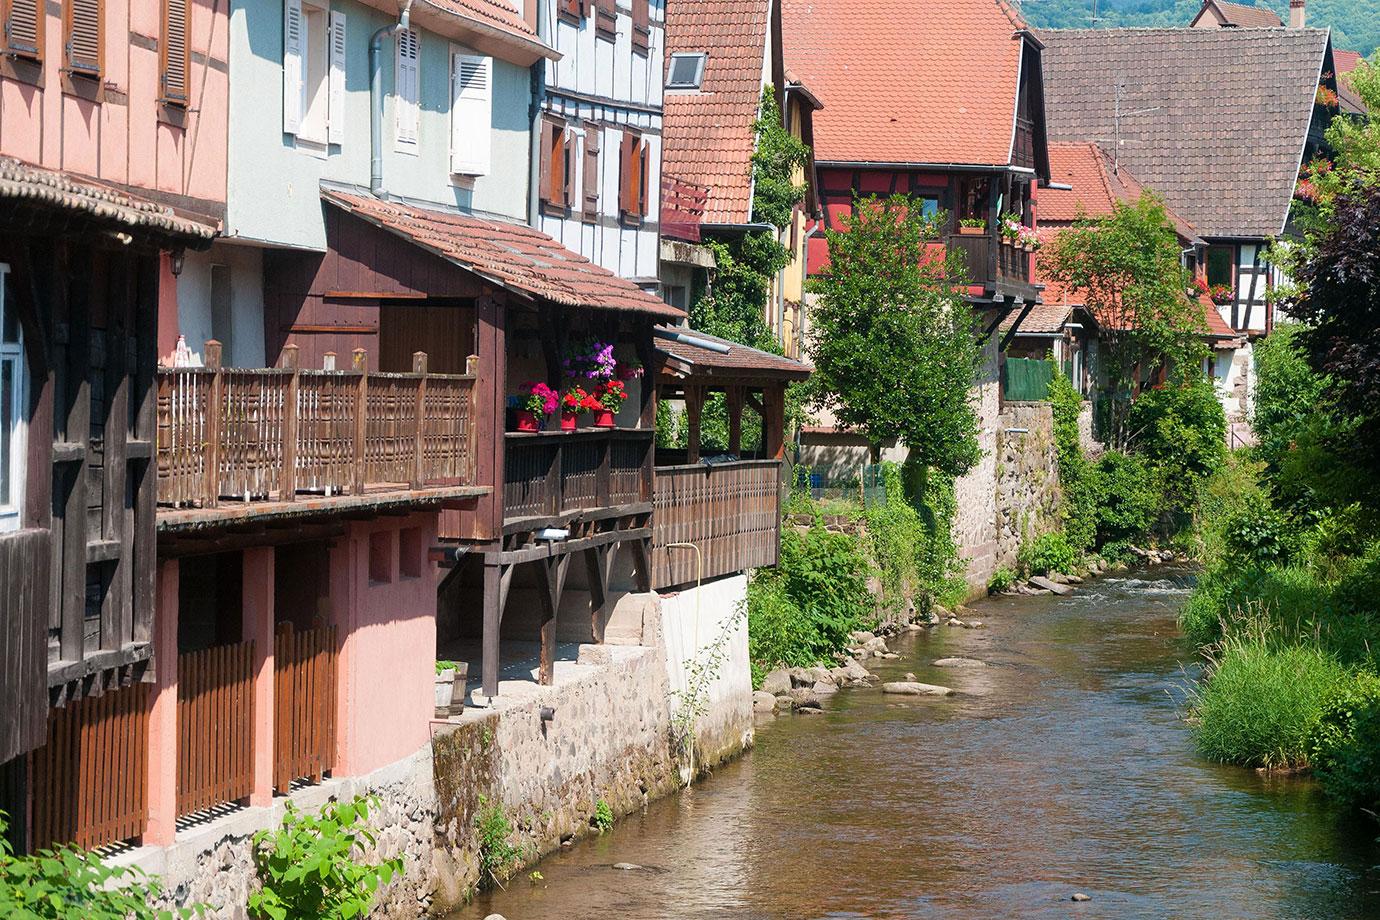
1041, 29, 1330, 237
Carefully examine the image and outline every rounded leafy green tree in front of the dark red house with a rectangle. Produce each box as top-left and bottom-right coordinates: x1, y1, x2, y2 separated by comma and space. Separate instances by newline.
809, 196, 981, 497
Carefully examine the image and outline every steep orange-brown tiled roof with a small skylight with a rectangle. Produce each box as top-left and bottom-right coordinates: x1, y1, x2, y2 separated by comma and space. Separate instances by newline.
661, 0, 771, 223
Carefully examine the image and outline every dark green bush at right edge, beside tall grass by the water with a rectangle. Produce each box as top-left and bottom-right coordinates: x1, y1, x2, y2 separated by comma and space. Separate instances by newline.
1312, 673, 1380, 810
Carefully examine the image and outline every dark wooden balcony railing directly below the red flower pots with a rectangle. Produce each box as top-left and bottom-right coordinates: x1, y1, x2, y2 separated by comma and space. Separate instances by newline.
504, 429, 653, 521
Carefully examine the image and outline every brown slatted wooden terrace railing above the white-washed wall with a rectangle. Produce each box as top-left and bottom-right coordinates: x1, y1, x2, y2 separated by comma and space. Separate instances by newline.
651, 461, 781, 588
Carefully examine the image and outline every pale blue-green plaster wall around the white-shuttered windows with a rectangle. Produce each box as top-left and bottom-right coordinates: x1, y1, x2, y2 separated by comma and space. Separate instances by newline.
226, 0, 531, 250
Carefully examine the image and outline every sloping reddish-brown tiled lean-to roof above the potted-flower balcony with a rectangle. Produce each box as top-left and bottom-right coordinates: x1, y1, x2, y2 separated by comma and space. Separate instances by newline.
322, 189, 684, 319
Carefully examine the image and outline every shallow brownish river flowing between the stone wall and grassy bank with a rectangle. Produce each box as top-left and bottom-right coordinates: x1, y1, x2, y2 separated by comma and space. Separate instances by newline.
455, 571, 1380, 920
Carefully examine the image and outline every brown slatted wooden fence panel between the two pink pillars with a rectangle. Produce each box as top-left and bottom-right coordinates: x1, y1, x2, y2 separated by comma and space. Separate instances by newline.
177, 641, 254, 817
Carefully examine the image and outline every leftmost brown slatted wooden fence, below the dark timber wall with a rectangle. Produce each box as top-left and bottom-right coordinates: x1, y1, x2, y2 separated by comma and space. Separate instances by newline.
29, 684, 149, 850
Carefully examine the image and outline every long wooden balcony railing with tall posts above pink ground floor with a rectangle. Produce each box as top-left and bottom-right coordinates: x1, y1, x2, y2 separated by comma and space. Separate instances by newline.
159, 342, 475, 508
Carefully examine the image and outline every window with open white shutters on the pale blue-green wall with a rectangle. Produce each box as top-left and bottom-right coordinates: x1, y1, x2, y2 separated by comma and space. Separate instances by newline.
283, 0, 345, 143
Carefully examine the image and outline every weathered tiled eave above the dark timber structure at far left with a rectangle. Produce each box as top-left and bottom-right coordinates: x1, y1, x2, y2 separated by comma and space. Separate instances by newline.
0, 157, 219, 244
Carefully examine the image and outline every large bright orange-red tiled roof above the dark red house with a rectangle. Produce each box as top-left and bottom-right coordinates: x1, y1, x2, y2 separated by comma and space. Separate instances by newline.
782, 0, 1027, 166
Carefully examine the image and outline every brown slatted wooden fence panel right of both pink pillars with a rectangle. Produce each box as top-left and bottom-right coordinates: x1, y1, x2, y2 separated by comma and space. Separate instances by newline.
273, 623, 338, 793
